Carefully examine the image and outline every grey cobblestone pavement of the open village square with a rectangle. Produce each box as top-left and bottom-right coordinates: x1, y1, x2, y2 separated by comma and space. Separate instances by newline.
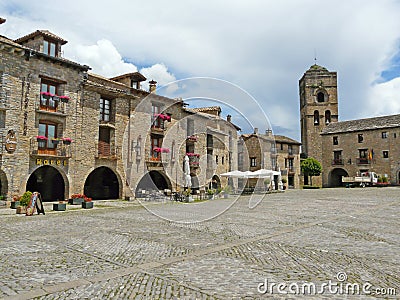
0, 188, 400, 299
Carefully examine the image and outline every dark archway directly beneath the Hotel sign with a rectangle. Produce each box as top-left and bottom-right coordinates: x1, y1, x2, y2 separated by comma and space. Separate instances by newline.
26, 166, 65, 201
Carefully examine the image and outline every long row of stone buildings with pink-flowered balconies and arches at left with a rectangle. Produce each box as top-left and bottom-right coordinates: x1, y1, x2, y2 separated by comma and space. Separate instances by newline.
0, 25, 239, 201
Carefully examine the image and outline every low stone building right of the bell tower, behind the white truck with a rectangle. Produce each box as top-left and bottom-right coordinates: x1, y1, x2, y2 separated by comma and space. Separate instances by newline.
321, 115, 400, 186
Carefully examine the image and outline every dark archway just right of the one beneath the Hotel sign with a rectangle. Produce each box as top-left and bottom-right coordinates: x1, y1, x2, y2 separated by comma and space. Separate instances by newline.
84, 167, 119, 200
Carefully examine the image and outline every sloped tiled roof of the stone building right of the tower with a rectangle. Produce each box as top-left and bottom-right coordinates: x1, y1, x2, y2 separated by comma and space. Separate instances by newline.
321, 114, 400, 134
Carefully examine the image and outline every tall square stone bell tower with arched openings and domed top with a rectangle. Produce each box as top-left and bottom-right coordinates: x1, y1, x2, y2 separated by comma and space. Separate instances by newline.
299, 64, 338, 162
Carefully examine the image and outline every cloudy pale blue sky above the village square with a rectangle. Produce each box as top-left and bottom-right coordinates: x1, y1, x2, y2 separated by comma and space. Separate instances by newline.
0, 0, 400, 139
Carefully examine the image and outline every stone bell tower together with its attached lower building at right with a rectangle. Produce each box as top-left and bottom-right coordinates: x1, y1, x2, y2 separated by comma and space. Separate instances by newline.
299, 65, 400, 187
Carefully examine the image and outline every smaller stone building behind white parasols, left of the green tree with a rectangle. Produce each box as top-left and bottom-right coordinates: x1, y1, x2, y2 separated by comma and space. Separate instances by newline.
238, 128, 300, 188
